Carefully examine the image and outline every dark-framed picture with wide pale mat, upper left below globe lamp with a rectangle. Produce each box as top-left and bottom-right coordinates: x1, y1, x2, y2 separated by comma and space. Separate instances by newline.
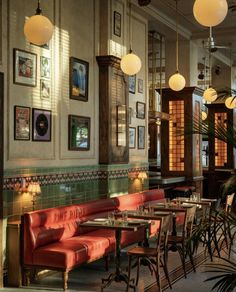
13, 49, 37, 87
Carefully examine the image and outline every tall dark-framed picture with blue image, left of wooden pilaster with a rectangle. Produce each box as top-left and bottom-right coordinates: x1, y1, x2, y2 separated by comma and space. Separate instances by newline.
70, 57, 89, 101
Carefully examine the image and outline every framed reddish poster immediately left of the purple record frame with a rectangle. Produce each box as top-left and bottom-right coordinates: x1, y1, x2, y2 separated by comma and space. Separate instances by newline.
14, 105, 30, 140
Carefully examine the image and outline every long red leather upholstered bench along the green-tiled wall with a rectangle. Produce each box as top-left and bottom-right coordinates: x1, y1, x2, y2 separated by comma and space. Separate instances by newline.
21, 189, 164, 290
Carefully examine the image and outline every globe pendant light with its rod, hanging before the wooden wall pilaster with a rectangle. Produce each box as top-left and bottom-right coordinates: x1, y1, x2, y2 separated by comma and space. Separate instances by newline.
120, 2, 142, 75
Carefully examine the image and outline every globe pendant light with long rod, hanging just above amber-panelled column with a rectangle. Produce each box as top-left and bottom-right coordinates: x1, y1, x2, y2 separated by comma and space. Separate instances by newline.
169, 0, 186, 91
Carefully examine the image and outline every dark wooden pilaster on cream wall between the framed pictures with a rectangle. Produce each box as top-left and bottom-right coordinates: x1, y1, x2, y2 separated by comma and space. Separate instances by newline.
97, 56, 129, 164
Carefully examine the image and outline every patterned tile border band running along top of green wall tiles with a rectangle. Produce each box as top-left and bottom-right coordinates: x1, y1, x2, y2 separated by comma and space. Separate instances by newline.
3, 166, 148, 190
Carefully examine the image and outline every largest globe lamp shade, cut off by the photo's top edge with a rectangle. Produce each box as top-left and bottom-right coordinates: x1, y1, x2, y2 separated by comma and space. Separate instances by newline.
193, 0, 228, 26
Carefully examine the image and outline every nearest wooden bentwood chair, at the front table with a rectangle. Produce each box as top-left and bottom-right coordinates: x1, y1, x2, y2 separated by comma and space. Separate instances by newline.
126, 214, 172, 291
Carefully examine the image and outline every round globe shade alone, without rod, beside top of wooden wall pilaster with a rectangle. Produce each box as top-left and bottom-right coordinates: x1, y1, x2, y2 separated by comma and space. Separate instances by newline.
120, 53, 142, 75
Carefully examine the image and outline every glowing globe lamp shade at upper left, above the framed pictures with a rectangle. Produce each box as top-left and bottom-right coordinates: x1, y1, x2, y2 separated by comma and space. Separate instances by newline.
24, 15, 53, 46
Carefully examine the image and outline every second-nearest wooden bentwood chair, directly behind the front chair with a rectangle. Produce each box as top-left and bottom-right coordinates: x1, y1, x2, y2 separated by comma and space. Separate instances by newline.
168, 205, 197, 278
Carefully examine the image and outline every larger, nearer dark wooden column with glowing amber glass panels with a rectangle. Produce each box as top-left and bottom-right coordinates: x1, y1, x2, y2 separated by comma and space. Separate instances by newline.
161, 87, 203, 192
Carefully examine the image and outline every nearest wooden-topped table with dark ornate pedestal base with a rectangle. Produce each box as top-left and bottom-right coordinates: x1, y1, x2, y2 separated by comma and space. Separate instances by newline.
80, 220, 150, 291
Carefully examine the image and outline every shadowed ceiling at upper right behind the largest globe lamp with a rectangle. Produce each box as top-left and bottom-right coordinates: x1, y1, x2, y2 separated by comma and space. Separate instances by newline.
137, 0, 236, 64
